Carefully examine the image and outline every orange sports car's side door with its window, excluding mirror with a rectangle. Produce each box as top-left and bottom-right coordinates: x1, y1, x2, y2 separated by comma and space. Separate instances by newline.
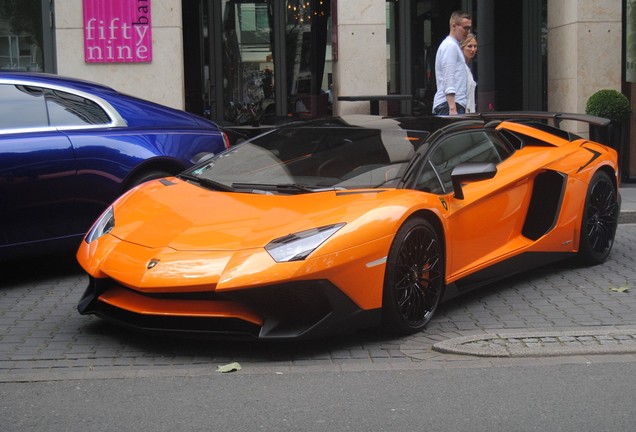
417, 130, 531, 281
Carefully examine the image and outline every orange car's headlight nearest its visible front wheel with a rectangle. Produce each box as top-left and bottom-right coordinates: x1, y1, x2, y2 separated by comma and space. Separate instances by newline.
265, 223, 345, 262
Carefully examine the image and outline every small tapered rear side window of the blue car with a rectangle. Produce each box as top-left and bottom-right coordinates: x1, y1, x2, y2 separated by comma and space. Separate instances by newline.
46, 90, 110, 127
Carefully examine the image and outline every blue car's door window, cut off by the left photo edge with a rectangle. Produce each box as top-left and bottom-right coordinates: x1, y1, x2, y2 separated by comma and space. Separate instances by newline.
0, 84, 49, 129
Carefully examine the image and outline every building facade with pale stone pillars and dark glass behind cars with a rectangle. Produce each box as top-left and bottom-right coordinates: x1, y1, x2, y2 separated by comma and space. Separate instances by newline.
0, 0, 636, 179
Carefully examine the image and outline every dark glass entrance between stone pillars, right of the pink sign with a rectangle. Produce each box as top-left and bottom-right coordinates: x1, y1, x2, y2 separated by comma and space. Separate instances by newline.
182, 0, 331, 126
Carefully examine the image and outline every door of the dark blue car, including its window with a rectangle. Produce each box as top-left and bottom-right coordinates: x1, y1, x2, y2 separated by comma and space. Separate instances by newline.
0, 83, 76, 248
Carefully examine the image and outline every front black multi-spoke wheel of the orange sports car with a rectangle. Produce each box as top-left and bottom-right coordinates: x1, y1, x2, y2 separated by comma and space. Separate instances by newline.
382, 217, 445, 334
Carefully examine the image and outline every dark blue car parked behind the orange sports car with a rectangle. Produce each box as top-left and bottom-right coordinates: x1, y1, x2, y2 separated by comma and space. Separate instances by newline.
0, 72, 229, 260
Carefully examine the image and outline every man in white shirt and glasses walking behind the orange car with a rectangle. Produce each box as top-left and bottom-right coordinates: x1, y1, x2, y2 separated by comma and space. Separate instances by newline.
433, 11, 472, 115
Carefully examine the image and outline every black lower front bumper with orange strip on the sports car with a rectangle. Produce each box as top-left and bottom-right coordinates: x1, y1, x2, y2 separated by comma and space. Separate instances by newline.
78, 277, 381, 339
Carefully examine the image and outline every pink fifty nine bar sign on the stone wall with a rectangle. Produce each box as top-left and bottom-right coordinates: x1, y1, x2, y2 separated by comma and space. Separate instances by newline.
83, 0, 152, 63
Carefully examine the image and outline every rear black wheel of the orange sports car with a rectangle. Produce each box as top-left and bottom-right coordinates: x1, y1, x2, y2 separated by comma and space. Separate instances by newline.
578, 171, 619, 266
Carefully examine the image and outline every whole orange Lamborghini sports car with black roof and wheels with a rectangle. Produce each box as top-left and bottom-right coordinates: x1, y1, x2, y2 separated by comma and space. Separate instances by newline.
77, 113, 620, 339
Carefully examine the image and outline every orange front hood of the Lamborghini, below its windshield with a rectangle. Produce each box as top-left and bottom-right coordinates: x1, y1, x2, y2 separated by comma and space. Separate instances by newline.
111, 179, 405, 251
